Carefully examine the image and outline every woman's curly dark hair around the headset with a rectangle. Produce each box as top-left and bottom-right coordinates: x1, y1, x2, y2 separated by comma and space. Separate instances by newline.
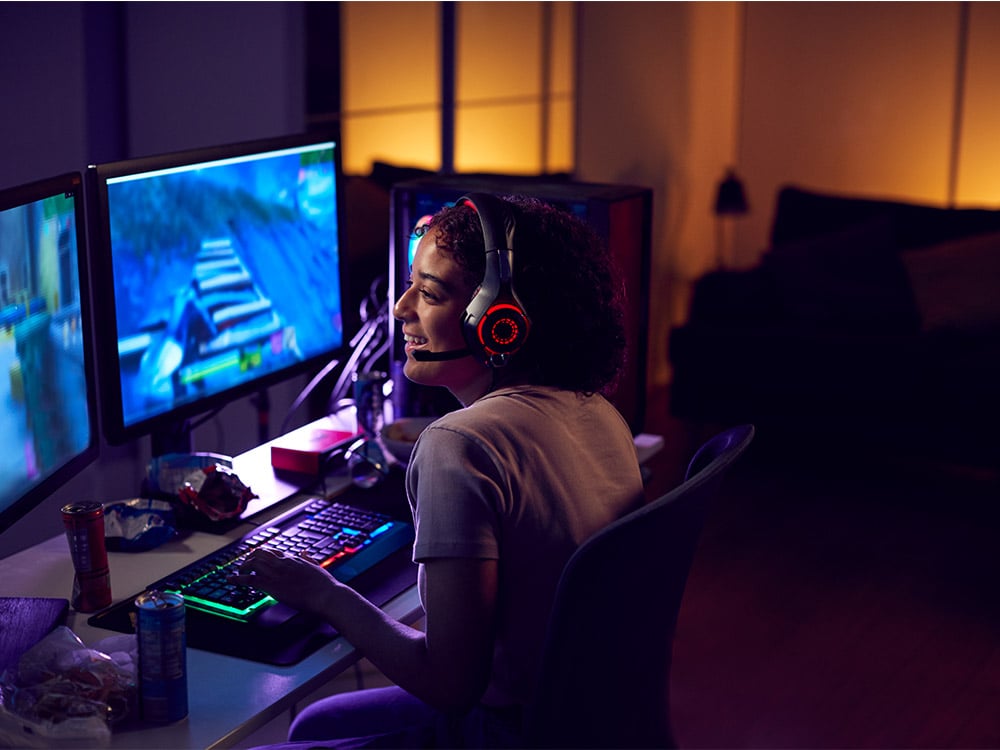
428, 195, 626, 395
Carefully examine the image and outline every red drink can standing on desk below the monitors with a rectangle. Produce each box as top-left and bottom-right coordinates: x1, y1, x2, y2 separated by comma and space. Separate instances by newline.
62, 503, 111, 612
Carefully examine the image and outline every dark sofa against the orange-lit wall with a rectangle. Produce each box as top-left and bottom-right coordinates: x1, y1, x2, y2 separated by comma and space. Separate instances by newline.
669, 186, 1000, 467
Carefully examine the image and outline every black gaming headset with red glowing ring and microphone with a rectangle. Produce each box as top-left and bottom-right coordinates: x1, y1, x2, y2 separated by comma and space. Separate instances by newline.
413, 193, 531, 367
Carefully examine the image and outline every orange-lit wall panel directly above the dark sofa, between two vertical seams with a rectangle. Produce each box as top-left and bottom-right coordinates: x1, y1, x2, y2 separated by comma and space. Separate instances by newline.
736, 2, 959, 264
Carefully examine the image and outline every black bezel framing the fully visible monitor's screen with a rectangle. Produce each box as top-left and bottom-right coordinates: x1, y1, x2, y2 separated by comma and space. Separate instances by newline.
86, 127, 351, 448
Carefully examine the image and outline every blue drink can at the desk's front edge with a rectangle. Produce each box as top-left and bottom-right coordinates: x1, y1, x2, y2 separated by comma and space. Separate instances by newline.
135, 591, 188, 724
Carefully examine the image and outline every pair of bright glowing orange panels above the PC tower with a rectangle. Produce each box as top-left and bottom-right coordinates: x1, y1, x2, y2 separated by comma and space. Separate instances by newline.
341, 2, 576, 174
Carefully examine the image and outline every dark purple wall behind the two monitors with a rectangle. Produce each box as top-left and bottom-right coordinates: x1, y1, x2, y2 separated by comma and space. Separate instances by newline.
0, 2, 305, 560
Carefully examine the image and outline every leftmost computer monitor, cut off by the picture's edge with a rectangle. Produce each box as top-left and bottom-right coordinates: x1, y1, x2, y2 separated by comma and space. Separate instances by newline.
0, 172, 98, 533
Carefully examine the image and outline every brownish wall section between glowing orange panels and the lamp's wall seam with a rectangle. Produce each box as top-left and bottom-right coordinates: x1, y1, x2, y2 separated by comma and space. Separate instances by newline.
576, 2, 739, 394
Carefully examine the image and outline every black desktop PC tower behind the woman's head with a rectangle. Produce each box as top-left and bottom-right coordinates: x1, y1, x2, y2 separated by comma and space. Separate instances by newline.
389, 175, 653, 434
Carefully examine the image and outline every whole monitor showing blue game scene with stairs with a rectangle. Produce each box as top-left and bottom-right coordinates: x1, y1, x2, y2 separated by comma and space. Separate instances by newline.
87, 133, 345, 455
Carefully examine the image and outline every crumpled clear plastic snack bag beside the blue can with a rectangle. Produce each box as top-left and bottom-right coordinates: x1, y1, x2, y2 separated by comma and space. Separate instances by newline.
0, 625, 138, 747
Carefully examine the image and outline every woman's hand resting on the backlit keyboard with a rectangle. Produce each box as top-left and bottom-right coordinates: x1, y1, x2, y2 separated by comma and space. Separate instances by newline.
229, 549, 344, 614
